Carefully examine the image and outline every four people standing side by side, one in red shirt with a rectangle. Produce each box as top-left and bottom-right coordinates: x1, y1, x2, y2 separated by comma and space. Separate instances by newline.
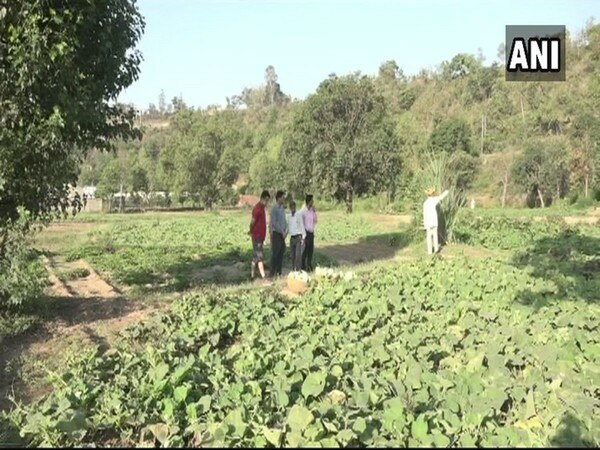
248, 191, 317, 280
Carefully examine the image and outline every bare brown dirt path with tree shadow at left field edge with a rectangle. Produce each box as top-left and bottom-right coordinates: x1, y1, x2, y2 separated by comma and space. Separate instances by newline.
0, 256, 161, 411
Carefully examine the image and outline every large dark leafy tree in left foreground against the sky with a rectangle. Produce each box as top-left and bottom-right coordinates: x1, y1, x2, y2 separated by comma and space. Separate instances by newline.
0, 0, 144, 243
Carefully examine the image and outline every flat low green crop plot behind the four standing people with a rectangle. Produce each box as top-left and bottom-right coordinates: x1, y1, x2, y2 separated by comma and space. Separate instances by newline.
59, 213, 398, 291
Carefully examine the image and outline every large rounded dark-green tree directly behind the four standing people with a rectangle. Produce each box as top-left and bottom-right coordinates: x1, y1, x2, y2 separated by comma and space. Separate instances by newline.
282, 74, 400, 213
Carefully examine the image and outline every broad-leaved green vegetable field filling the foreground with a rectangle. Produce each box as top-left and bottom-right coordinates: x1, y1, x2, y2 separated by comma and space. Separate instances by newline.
2, 211, 600, 447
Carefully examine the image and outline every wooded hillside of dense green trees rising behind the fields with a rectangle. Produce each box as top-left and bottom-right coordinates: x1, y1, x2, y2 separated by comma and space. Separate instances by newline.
81, 19, 600, 209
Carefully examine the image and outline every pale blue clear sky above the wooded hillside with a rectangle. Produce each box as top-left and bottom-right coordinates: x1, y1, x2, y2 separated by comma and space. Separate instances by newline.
119, 0, 600, 109
